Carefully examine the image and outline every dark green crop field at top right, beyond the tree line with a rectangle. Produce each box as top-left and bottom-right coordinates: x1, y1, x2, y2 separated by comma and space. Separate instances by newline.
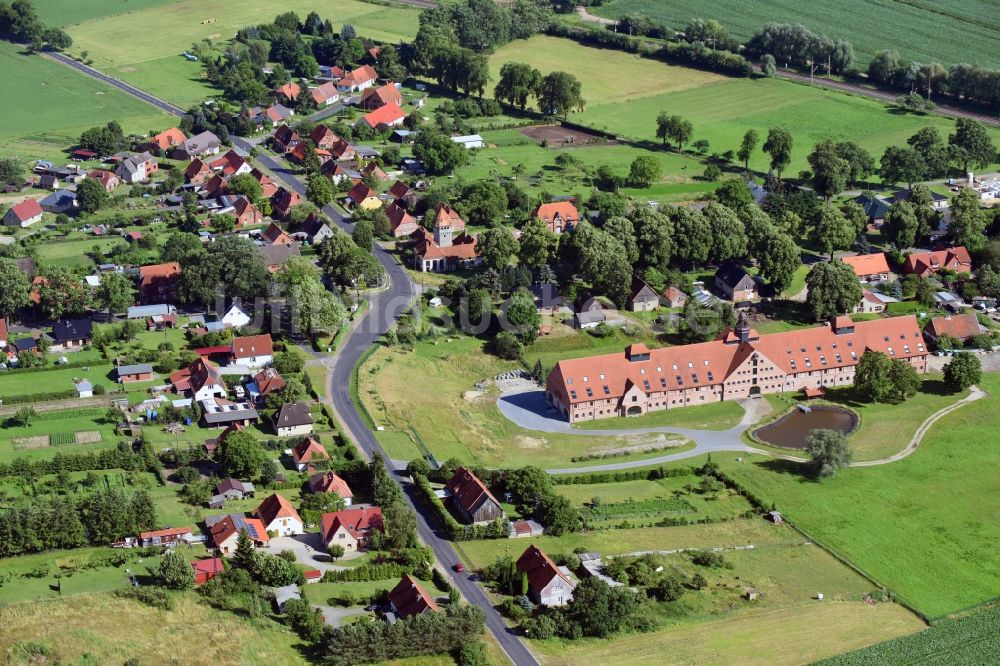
590, 0, 1000, 68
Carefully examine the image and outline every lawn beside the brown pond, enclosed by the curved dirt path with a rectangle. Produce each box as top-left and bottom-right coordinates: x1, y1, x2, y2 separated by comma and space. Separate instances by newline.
766, 375, 967, 460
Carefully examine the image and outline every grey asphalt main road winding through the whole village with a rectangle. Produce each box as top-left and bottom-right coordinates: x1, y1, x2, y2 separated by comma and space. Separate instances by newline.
46, 52, 538, 666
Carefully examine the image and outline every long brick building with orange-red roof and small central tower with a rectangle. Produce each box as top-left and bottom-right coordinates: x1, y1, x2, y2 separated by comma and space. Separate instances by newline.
545, 315, 927, 423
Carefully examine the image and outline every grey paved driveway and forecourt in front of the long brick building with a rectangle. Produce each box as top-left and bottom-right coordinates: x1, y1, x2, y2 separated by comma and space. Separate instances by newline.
497, 390, 771, 474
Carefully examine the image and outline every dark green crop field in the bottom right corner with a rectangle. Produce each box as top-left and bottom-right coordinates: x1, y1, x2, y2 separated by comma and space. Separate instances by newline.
816, 607, 1000, 666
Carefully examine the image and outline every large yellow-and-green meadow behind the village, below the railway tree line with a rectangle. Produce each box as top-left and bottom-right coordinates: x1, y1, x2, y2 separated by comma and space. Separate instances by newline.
490, 36, 1000, 175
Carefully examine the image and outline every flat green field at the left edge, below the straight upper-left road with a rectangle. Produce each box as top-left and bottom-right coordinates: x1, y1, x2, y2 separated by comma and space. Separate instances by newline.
0, 42, 169, 160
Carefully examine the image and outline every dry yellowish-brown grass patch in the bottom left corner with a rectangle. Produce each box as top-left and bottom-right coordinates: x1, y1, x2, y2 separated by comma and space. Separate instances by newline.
0, 592, 303, 666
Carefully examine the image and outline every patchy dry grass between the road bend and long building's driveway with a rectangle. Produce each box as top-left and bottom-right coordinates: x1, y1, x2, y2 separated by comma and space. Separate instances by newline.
358, 336, 704, 467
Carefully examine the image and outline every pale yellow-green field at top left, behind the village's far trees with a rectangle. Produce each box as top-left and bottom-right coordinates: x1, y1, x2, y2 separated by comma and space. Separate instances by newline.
67, 0, 418, 107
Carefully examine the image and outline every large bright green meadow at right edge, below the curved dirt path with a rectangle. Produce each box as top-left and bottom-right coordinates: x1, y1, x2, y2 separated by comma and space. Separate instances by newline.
713, 374, 1000, 618
